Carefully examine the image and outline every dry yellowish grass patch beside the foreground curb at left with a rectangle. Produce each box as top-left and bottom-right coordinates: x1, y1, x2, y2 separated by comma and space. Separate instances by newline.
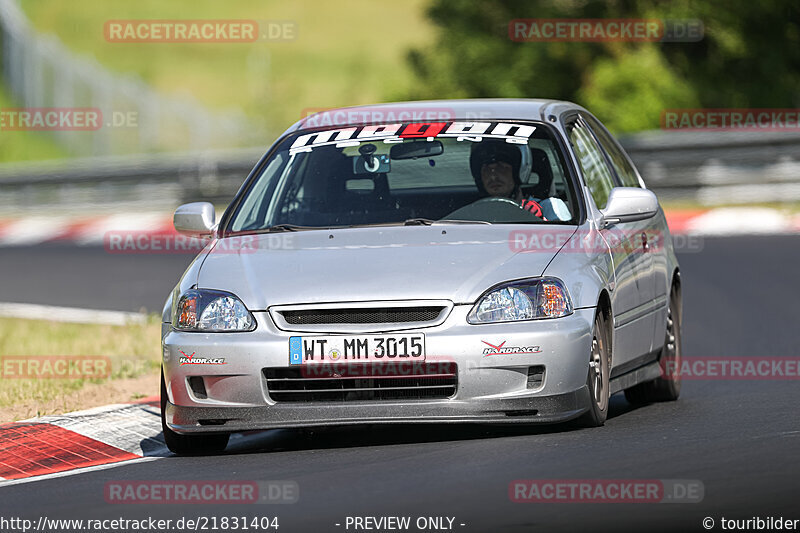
0, 317, 161, 414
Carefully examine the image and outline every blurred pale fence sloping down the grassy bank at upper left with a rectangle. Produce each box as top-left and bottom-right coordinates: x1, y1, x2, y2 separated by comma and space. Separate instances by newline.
0, 0, 256, 156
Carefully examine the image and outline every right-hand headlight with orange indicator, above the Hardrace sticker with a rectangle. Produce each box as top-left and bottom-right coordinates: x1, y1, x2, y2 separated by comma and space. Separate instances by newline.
467, 278, 572, 324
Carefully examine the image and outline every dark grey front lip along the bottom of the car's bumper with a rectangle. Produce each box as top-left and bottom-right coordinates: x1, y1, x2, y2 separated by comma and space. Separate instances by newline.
165, 385, 590, 434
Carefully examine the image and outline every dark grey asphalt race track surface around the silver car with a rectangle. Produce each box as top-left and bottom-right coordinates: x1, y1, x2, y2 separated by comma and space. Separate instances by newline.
0, 236, 800, 533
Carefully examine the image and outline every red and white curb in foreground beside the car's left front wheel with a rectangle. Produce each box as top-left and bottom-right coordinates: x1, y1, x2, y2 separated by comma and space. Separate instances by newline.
0, 398, 169, 486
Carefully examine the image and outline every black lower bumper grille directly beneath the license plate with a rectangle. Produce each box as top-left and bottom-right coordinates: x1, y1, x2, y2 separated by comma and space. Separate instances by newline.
263, 362, 458, 402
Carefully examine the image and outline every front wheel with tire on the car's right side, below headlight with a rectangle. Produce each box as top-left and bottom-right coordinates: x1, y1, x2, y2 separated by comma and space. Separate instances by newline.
578, 311, 611, 427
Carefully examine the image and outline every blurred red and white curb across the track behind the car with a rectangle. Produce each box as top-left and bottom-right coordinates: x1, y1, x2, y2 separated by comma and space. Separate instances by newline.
0, 207, 800, 246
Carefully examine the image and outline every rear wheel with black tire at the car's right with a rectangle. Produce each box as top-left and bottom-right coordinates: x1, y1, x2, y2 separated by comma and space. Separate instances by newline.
625, 285, 682, 405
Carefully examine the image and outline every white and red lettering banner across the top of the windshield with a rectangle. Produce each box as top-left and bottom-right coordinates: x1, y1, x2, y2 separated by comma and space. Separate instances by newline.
289, 122, 536, 155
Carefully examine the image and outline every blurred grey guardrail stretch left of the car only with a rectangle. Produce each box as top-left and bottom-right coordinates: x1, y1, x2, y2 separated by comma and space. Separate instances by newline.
0, 148, 264, 217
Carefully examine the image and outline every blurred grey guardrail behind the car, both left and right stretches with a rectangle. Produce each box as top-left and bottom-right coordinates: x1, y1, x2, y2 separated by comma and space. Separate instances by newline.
0, 132, 800, 216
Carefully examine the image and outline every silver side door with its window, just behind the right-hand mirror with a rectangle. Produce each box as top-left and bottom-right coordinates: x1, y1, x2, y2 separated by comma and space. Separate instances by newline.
567, 117, 653, 368
